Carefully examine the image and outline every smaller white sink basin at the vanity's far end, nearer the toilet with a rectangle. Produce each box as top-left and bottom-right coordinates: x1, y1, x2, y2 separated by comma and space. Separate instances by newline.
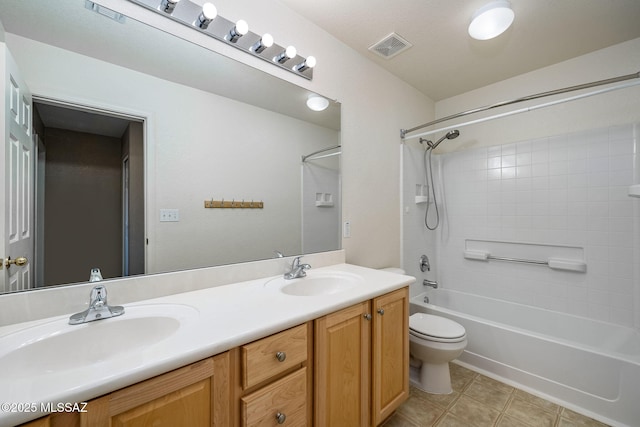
274, 272, 364, 296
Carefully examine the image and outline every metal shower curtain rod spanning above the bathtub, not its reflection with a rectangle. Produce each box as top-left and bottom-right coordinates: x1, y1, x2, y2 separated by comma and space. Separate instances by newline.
400, 71, 640, 139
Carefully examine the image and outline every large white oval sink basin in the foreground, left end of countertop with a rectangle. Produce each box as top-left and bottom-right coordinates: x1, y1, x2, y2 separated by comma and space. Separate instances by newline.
0, 304, 198, 378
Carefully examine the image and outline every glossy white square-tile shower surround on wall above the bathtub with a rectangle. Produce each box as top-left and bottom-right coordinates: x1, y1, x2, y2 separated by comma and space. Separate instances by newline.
422, 124, 640, 326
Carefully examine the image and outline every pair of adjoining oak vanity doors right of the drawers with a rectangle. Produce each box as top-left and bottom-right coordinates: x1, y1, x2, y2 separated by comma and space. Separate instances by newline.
314, 288, 409, 427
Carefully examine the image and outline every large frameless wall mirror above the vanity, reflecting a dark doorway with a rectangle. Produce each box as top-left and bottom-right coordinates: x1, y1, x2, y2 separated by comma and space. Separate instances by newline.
0, 0, 341, 292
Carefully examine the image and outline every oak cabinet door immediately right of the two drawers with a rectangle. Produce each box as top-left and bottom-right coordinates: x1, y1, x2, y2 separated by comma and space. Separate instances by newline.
314, 301, 371, 427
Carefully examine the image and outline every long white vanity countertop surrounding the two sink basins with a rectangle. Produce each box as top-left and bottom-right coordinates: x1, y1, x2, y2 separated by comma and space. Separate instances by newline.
0, 264, 415, 426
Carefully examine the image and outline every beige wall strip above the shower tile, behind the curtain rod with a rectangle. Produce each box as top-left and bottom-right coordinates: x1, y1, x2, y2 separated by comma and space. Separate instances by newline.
436, 38, 640, 152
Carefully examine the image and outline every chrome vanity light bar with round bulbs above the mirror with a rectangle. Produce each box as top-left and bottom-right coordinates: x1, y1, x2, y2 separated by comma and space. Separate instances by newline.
129, 0, 316, 80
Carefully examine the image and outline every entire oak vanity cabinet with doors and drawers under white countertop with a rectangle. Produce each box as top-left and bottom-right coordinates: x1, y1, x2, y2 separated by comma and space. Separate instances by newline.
24, 288, 409, 427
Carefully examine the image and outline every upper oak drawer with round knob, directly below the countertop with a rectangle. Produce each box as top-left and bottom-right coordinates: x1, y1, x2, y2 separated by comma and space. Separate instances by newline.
242, 324, 308, 389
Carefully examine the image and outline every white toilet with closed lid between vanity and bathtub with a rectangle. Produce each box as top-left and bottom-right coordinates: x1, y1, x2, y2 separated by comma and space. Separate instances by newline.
409, 313, 467, 394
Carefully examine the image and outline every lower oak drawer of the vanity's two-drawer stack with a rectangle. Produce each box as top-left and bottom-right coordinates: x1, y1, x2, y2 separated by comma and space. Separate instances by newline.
242, 367, 307, 427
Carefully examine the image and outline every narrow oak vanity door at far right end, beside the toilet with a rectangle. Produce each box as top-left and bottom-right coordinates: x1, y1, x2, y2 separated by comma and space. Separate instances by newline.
372, 288, 409, 425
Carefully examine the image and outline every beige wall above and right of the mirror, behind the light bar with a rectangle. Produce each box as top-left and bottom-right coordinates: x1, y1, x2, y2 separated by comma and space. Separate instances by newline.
98, 0, 434, 267
